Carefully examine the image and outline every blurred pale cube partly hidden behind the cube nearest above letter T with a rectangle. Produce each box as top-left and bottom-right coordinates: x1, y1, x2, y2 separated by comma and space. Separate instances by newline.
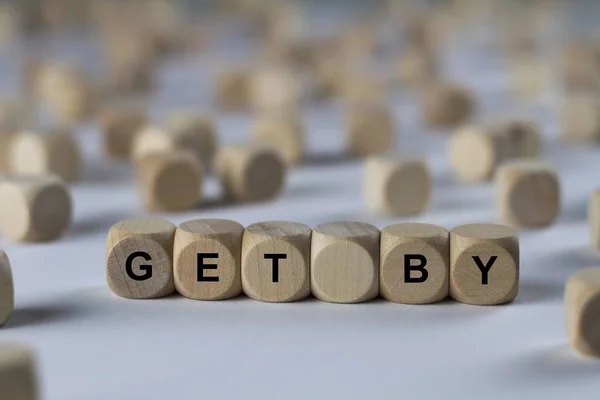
254, 114, 305, 165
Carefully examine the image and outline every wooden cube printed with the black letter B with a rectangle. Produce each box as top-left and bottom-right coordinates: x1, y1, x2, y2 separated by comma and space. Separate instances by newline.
379, 223, 450, 304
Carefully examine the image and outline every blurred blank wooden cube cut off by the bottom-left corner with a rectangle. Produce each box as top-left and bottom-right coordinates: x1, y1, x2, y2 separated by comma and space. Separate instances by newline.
0, 342, 39, 400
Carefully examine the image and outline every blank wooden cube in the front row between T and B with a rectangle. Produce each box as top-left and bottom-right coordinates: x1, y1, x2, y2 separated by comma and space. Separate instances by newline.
311, 222, 380, 303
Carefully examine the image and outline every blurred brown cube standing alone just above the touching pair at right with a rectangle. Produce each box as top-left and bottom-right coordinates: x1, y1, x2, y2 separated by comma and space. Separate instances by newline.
423, 83, 475, 129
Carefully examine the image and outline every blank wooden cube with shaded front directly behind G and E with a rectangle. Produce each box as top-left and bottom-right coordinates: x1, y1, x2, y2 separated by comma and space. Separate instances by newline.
136, 151, 203, 211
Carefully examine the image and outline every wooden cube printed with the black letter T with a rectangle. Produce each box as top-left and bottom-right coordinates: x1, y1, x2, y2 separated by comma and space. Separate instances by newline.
242, 221, 312, 303
